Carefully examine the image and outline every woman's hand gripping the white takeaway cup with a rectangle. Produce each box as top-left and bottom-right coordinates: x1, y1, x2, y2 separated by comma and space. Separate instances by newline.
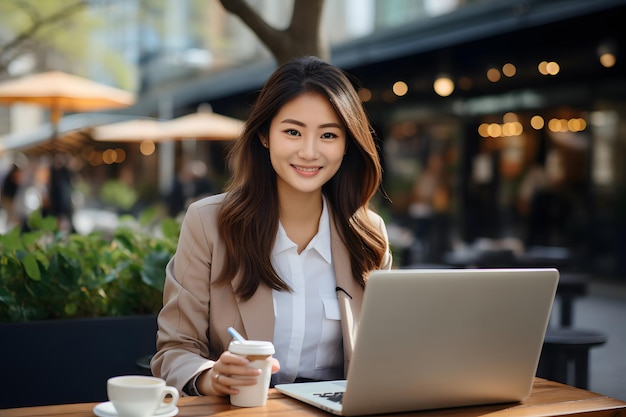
196, 351, 280, 395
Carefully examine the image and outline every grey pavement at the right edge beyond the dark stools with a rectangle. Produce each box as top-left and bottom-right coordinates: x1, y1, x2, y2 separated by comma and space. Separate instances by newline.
553, 277, 626, 401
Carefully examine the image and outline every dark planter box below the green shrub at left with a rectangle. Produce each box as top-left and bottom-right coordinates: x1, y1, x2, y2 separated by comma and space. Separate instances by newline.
0, 315, 157, 408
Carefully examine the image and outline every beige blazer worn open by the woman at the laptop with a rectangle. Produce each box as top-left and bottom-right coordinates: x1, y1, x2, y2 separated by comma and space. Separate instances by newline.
151, 194, 392, 392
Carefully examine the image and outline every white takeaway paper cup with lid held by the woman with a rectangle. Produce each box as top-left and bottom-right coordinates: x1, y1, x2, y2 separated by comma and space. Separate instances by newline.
228, 340, 274, 407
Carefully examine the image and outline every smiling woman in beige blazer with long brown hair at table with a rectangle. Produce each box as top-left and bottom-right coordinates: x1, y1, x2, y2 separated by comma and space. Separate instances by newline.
152, 57, 392, 395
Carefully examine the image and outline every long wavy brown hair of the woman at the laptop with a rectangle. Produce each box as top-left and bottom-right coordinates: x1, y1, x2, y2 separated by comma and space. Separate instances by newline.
218, 57, 387, 300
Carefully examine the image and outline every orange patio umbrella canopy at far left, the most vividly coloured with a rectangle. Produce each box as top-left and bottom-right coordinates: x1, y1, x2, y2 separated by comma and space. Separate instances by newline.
0, 71, 135, 125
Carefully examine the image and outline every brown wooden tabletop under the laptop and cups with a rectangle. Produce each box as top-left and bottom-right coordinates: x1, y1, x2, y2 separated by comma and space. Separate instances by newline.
0, 378, 626, 417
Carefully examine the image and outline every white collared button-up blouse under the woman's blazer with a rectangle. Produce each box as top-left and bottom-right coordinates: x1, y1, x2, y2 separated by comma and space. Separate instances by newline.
272, 200, 343, 385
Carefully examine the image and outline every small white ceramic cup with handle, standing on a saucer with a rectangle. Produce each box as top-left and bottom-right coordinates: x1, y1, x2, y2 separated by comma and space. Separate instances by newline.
107, 375, 179, 417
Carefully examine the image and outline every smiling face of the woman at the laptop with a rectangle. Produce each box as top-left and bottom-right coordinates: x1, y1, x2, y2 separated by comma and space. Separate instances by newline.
262, 93, 346, 197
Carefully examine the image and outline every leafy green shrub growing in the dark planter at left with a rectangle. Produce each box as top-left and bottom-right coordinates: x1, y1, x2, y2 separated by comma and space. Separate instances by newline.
0, 210, 180, 322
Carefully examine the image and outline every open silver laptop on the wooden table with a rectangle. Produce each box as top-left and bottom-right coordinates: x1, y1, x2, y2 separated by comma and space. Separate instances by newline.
275, 268, 559, 416
